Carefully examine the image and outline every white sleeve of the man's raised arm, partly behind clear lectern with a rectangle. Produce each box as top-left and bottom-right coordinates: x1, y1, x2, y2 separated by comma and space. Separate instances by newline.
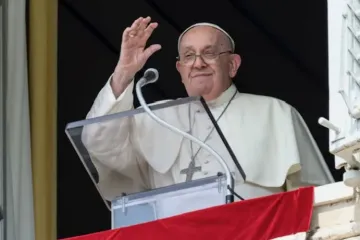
81, 77, 148, 193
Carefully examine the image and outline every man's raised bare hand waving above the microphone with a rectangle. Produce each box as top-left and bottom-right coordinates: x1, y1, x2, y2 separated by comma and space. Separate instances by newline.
111, 17, 161, 97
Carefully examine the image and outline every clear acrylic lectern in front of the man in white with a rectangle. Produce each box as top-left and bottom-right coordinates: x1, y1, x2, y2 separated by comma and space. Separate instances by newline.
66, 97, 245, 228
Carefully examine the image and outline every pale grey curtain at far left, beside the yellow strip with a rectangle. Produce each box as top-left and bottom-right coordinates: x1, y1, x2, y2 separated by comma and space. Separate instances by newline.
1, 0, 35, 240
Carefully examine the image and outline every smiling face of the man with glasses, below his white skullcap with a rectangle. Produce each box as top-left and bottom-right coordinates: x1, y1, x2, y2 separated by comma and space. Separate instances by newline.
176, 26, 241, 101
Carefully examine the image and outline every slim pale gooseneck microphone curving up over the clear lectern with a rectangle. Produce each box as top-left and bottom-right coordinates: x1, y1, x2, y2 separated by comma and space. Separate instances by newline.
136, 68, 234, 203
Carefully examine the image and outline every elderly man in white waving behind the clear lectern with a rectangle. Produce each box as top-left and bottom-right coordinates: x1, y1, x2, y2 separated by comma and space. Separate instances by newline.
82, 17, 333, 199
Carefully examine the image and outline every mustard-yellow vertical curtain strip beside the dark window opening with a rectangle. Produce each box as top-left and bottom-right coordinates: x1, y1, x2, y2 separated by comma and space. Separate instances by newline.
28, 0, 58, 240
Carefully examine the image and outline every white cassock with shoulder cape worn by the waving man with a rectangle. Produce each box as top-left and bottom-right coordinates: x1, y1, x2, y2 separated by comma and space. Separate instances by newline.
82, 74, 334, 200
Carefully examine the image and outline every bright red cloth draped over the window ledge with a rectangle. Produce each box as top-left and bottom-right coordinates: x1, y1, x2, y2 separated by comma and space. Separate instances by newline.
60, 187, 314, 240
